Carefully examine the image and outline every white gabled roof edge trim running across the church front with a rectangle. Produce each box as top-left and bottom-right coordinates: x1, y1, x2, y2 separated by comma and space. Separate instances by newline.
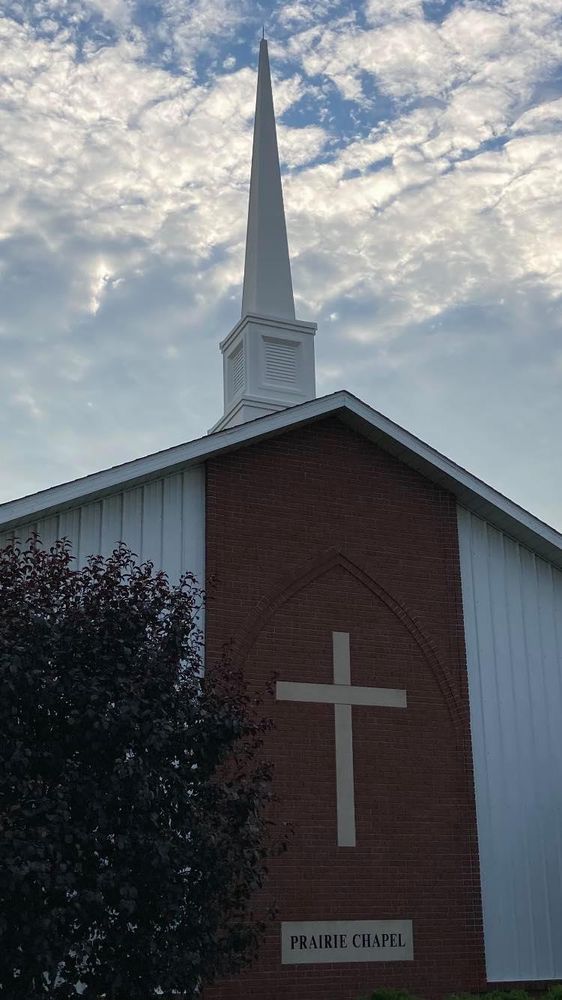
0, 390, 562, 568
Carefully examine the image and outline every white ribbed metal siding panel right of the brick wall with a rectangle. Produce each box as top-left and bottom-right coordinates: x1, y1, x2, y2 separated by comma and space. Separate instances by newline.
459, 508, 562, 981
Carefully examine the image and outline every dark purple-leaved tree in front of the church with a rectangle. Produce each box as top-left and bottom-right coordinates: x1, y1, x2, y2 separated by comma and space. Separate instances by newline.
0, 537, 270, 1000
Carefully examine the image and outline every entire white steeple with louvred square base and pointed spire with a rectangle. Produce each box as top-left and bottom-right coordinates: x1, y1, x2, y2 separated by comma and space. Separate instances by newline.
213, 38, 316, 431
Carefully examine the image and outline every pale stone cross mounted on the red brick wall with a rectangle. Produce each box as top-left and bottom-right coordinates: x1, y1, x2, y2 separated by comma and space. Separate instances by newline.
276, 632, 407, 847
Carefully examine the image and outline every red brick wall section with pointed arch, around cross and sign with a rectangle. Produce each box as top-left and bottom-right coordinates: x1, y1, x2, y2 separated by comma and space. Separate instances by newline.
206, 417, 485, 1000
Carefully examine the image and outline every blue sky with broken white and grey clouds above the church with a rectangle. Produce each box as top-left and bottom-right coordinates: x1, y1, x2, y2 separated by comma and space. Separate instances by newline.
0, 0, 562, 530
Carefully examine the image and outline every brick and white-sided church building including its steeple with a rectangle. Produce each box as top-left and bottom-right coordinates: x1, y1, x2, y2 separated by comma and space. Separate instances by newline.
0, 40, 562, 1000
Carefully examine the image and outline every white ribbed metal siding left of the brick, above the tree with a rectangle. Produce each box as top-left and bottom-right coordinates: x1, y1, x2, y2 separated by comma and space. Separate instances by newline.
0, 465, 205, 585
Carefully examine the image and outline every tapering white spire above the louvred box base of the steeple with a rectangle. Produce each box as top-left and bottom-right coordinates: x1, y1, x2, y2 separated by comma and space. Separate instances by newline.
242, 38, 295, 319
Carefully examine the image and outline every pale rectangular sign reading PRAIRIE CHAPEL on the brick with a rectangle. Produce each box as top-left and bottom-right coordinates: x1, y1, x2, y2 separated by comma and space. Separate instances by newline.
281, 920, 414, 965
